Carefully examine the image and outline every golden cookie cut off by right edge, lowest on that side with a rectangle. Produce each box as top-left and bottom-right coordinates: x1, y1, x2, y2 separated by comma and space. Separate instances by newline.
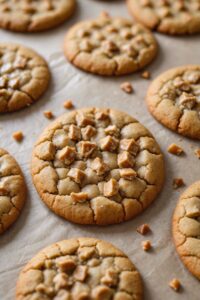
172, 181, 200, 280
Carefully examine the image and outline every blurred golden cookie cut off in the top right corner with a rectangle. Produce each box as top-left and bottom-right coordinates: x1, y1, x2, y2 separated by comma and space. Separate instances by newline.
127, 0, 200, 34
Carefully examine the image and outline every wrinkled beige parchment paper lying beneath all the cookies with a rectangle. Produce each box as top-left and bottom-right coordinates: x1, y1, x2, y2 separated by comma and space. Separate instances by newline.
0, 0, 200, 300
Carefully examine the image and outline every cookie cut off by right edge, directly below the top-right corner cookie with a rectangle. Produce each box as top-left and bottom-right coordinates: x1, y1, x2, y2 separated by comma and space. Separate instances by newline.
146, 65, 200, 139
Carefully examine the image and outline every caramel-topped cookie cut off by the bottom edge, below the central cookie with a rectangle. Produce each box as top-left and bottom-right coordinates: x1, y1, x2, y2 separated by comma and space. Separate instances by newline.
16, 238, 143, 300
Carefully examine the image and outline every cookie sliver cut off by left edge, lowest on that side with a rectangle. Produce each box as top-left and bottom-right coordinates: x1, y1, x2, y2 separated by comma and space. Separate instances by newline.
0, 148, 26, 234
